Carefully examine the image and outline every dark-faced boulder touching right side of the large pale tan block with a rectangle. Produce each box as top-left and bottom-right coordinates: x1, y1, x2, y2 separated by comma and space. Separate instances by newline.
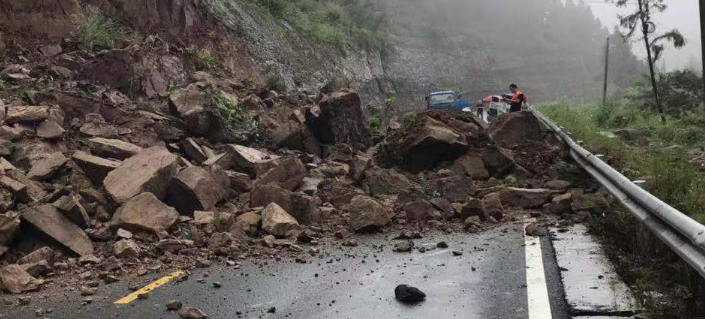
167, 166, 229, 215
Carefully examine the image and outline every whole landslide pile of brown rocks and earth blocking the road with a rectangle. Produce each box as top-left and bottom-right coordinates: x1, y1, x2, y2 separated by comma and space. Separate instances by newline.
0, 39, 594, 295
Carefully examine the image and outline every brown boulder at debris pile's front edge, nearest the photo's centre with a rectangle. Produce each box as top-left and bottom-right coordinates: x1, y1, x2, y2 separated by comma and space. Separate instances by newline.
348, 195, 392, 232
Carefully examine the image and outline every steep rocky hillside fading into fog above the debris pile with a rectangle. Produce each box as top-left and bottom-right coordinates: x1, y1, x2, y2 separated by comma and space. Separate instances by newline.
0, 0, 640, 111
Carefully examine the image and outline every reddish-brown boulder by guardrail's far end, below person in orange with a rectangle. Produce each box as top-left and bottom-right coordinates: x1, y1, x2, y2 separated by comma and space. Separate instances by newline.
489, 112, 543, 148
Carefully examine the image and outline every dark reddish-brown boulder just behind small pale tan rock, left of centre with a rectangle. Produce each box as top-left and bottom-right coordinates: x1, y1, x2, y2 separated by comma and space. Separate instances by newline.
250, 183, 321, 224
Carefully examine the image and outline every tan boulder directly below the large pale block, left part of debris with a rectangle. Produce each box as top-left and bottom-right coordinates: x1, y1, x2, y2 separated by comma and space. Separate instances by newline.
110, 193, 179, 233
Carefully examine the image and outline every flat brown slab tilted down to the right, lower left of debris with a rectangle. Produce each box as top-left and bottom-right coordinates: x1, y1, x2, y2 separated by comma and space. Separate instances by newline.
22, 205, 93, 256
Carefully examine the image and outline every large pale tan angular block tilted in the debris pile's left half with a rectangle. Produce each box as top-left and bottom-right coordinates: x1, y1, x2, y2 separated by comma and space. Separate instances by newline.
103, 147, 178, 203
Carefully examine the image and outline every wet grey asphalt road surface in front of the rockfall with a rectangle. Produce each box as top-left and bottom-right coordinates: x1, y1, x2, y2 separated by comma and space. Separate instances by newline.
0, 224, 569, 319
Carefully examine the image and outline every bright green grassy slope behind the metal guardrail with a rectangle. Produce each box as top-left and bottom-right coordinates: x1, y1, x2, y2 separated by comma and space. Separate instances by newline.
540, 101, 705, 223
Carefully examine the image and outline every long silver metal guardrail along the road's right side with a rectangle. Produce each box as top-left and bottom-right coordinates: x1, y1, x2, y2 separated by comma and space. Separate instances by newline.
531, 108, 705, 278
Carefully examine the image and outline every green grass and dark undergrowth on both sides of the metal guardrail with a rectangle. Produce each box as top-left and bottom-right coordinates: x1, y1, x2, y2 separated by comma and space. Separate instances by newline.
540, 101, 705, 318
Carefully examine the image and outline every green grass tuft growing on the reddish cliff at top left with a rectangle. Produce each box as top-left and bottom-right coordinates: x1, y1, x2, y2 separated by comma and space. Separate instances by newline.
76, 7, 142, 52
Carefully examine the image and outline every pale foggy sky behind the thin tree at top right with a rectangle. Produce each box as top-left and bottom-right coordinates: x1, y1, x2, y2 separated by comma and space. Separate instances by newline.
585, 0, 701, 70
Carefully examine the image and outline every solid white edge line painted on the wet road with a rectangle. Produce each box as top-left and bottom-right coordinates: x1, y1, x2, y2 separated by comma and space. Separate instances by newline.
524, 225, 552, 319
